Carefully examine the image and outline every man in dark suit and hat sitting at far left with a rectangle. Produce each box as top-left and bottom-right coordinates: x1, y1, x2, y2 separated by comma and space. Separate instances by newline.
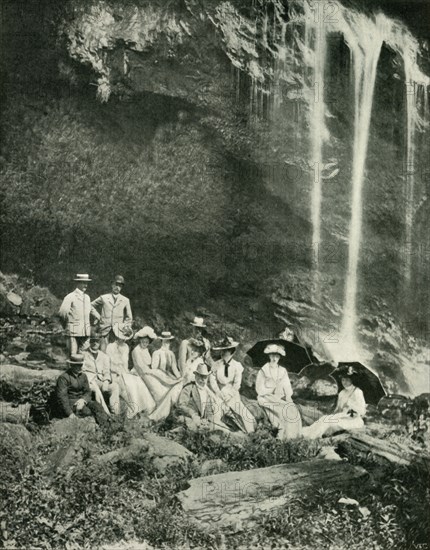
55, 354, 109, 427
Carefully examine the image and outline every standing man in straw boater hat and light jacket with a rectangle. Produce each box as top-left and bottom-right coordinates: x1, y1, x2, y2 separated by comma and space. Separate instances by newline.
59, 273, 99, 355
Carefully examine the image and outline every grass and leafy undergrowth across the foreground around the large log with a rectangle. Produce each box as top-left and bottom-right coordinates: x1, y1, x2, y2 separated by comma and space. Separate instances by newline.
0, 418, 430, 550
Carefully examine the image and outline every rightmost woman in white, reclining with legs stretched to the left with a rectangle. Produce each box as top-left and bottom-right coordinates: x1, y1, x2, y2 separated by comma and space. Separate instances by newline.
302, 367, 366, 439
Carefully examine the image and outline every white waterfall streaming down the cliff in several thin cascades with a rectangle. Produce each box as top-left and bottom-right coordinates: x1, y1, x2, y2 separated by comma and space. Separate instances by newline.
220, 0, 430, 359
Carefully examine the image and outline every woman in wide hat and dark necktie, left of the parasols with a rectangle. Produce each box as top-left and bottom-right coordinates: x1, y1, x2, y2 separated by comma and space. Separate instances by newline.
209, 337, 256, 433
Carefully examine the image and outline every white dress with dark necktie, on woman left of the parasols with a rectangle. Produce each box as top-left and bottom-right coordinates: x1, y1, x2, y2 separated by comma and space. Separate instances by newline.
209, 359, 256, 433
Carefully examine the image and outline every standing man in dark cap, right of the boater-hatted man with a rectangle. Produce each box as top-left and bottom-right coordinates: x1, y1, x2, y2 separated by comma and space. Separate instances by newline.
91, 275, 133, 351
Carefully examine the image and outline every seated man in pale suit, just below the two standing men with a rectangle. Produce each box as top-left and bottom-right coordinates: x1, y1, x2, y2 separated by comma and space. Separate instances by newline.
82, 335, 120, 414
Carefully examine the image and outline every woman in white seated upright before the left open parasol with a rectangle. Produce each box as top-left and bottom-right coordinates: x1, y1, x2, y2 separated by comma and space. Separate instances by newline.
255, 344, 302, 440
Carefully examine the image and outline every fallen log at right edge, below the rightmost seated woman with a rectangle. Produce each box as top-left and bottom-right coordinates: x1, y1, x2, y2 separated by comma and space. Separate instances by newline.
338, 432, 430, 466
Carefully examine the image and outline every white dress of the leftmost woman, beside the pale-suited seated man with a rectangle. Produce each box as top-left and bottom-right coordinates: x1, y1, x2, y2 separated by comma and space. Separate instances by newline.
106, 342, 155, 418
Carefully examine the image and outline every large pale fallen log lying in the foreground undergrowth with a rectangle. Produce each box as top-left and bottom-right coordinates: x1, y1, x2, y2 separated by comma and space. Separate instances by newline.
177, 459, 367, 531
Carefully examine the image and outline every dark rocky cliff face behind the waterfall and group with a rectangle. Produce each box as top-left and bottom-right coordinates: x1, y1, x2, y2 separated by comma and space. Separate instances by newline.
0, 0, 430, 398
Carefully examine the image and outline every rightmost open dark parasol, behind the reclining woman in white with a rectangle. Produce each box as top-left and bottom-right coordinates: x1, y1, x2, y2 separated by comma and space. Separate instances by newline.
332, 361, 387, 405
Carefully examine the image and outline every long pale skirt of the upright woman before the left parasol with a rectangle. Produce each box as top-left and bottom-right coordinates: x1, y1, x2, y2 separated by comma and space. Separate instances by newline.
258, 394, 302, 440
